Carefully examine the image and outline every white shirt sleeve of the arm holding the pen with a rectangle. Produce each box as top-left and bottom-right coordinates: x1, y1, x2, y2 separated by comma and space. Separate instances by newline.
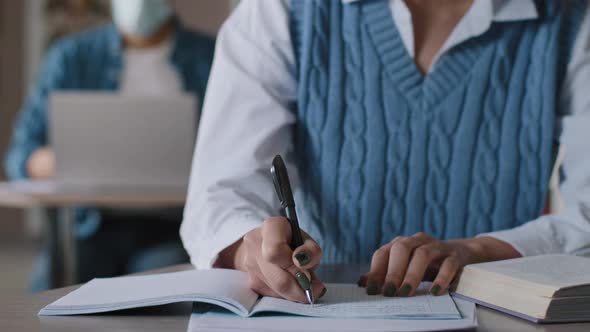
180, 0, 297, 268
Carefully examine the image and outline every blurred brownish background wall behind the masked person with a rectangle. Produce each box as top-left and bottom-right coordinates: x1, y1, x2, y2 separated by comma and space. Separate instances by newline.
0, 0, 237, 296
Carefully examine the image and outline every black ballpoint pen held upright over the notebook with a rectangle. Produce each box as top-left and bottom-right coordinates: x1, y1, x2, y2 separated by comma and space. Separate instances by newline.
270, 155, 314, 304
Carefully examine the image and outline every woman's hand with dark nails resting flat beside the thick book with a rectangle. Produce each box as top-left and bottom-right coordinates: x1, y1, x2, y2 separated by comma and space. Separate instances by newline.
359, 233, 520, 296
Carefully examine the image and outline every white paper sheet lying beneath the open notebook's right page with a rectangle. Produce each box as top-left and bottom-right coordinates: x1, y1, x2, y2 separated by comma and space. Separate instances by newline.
188, 299, 477, 332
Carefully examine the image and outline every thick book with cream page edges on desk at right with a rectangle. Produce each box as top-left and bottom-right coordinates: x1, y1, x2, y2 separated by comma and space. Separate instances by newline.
453, 255, 590, 323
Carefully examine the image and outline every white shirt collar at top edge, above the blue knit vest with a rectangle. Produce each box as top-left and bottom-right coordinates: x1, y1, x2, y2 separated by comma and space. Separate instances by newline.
341, 0, 539, 22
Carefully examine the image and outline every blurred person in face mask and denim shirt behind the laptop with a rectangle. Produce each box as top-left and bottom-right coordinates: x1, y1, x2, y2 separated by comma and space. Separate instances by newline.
5, 0, 214, 291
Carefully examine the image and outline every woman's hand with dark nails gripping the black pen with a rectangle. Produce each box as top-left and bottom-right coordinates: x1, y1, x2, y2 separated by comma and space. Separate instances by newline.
220, 217, 326, 303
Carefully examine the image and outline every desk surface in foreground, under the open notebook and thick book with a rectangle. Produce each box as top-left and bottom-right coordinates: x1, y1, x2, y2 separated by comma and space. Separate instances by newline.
0, 265, 590, 332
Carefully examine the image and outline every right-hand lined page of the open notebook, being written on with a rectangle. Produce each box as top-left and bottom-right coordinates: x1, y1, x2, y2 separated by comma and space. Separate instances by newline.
253, 283, 461, 319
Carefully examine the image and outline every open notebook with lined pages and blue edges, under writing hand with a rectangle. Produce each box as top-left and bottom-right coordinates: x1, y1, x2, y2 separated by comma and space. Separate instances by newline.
39, 269, 461, 319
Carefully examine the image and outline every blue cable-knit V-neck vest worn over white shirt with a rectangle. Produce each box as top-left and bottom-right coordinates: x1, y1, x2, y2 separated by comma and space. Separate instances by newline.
291, 0, 584, 263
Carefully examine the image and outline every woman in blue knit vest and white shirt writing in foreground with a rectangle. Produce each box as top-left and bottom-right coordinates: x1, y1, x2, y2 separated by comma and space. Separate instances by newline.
181, 0, 590, 302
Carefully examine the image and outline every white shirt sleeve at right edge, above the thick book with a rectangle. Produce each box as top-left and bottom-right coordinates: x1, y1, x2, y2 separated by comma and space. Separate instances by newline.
482, 5, 590, 256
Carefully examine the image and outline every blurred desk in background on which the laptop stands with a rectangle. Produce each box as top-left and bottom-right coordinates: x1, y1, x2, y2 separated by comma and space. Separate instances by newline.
0, 181, 186, 286
